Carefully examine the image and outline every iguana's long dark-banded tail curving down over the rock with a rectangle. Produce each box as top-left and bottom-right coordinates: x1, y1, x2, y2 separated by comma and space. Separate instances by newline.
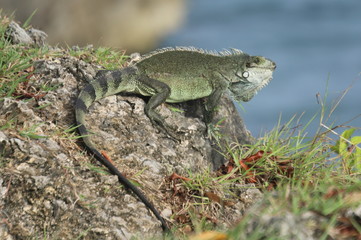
75, 72, 169, 231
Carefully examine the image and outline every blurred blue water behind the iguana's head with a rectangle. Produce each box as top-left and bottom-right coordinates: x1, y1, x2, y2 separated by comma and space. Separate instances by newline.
162, 0, 361, 136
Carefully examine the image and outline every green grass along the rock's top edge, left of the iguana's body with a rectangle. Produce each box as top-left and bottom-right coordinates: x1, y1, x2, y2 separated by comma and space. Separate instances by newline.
0, 10, 128, 100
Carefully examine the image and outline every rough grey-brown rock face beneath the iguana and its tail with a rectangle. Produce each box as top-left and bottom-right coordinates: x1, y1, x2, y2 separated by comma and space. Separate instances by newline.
0, 23, 261, 239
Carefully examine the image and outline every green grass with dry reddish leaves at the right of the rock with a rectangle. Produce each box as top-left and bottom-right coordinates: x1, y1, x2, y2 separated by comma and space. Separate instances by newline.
164, 91, 361, 239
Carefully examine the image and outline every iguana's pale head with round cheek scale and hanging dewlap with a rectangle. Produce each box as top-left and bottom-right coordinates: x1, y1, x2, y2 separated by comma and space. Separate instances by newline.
228, 56, 276, 102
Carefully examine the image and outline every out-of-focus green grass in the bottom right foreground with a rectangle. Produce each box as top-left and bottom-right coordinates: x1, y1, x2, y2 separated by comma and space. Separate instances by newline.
226, 174, 361, 239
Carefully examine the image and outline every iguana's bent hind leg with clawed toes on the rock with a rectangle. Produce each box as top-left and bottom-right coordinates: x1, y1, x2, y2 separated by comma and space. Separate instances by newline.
138, 76, 178, 139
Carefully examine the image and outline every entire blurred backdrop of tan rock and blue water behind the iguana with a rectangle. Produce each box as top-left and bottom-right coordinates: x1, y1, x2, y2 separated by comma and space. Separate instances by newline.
0, 0, 361, 136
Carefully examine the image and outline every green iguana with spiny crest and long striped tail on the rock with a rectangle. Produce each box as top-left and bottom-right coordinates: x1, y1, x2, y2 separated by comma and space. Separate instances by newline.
75, 47, 276, 230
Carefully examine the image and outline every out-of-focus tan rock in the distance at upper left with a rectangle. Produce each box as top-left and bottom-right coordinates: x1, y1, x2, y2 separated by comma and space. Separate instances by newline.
0, 0, 186, 52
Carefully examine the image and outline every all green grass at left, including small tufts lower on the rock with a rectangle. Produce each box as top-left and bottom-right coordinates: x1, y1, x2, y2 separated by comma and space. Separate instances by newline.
0, 12, 127, 139
